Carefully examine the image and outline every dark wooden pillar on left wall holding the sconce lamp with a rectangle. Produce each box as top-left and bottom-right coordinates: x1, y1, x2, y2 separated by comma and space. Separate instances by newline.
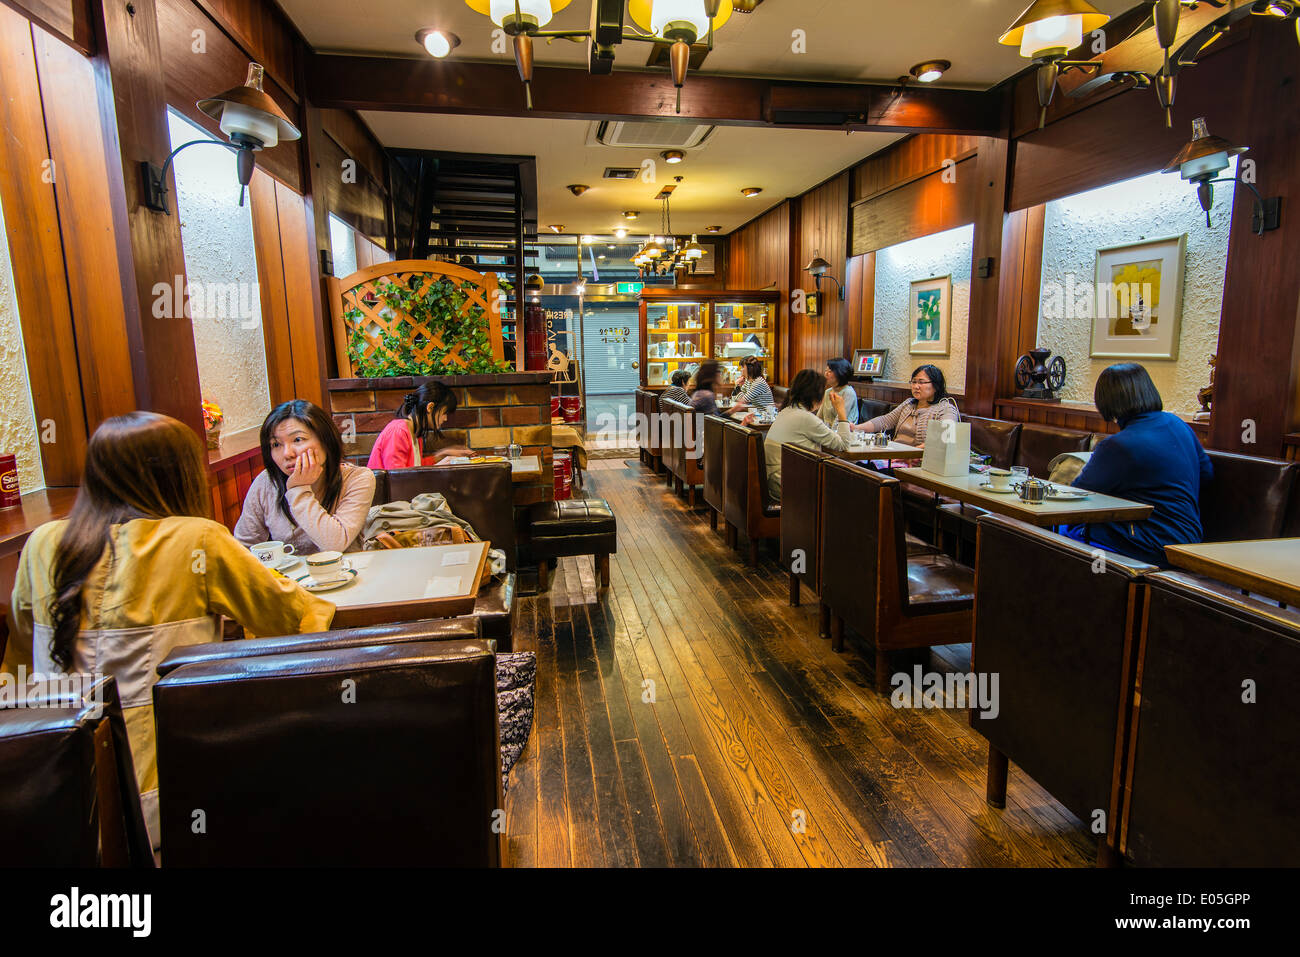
91, 0, 203, 434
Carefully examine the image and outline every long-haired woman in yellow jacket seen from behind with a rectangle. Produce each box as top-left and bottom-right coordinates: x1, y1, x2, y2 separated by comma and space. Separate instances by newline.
4, 412, 334, 848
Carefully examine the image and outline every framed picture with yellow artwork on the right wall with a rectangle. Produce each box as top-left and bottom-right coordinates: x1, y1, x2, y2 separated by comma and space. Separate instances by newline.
1092, 233, 1187, 359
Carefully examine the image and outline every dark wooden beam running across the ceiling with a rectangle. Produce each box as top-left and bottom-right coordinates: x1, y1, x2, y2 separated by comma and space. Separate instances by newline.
307, 53, 1002, 135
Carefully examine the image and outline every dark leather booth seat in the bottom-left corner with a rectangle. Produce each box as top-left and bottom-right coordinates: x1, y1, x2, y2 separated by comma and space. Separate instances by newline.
0, 676, 153, 867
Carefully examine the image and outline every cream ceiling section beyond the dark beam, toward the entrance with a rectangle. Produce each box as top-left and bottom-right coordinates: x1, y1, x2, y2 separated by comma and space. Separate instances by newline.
361, 112, 898, 234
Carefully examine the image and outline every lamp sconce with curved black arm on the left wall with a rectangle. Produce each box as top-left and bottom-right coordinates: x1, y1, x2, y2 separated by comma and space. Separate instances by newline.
140, 64, 303, 215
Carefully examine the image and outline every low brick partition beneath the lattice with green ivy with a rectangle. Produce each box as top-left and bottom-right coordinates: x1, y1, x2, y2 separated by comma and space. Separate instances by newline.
328, 372, 555, 506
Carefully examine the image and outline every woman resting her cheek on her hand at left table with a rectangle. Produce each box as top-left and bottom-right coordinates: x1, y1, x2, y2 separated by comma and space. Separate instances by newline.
235, 399, 374, 555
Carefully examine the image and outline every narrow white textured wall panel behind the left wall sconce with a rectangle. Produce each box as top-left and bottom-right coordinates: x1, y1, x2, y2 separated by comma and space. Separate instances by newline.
168, 113, 270, 437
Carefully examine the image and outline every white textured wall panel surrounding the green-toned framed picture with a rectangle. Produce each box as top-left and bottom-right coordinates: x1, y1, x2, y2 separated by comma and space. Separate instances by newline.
872, 225, 975, 393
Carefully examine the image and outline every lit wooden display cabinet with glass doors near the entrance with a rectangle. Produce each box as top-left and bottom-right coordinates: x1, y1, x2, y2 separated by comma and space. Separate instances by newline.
641, 289, 781, 389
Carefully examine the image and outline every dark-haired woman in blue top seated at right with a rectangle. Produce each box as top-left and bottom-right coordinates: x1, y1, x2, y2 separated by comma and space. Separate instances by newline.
1065, 363, 1214, 568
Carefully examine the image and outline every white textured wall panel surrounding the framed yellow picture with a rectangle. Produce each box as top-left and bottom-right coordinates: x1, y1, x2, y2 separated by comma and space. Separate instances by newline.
1037, 163, 1232, 415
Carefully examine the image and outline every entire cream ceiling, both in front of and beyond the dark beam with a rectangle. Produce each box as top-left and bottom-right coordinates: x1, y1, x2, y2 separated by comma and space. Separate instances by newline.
281, 0, 1134, 233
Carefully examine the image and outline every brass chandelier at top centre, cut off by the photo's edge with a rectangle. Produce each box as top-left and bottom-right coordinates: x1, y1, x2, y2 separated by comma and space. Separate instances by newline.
465, 0, 732, 113
